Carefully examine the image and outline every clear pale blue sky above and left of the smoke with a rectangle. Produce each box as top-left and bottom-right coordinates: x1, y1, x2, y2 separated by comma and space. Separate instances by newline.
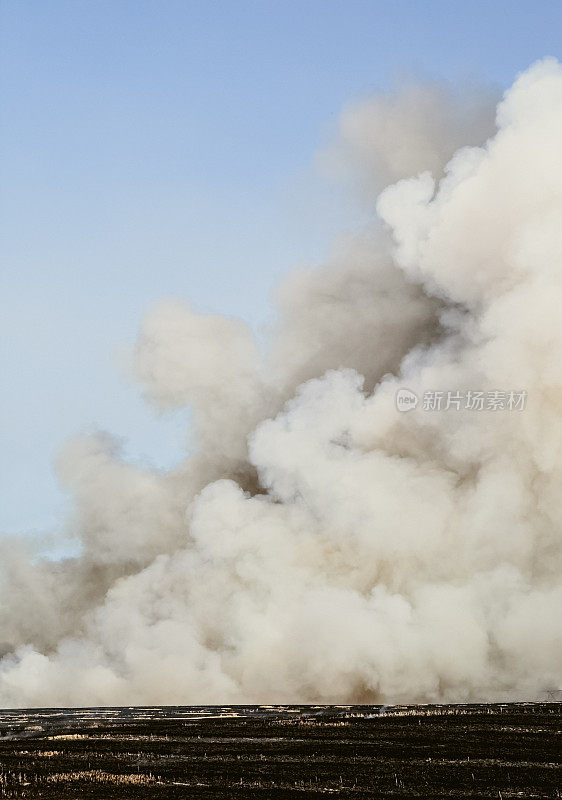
0, 0, 562, 532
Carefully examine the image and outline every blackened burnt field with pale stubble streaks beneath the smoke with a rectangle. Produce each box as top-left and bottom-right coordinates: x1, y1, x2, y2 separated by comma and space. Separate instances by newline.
0, 703, 562, 800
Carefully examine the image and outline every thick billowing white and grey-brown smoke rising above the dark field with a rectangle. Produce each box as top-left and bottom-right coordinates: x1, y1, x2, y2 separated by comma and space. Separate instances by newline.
0, 60, 562, 706
